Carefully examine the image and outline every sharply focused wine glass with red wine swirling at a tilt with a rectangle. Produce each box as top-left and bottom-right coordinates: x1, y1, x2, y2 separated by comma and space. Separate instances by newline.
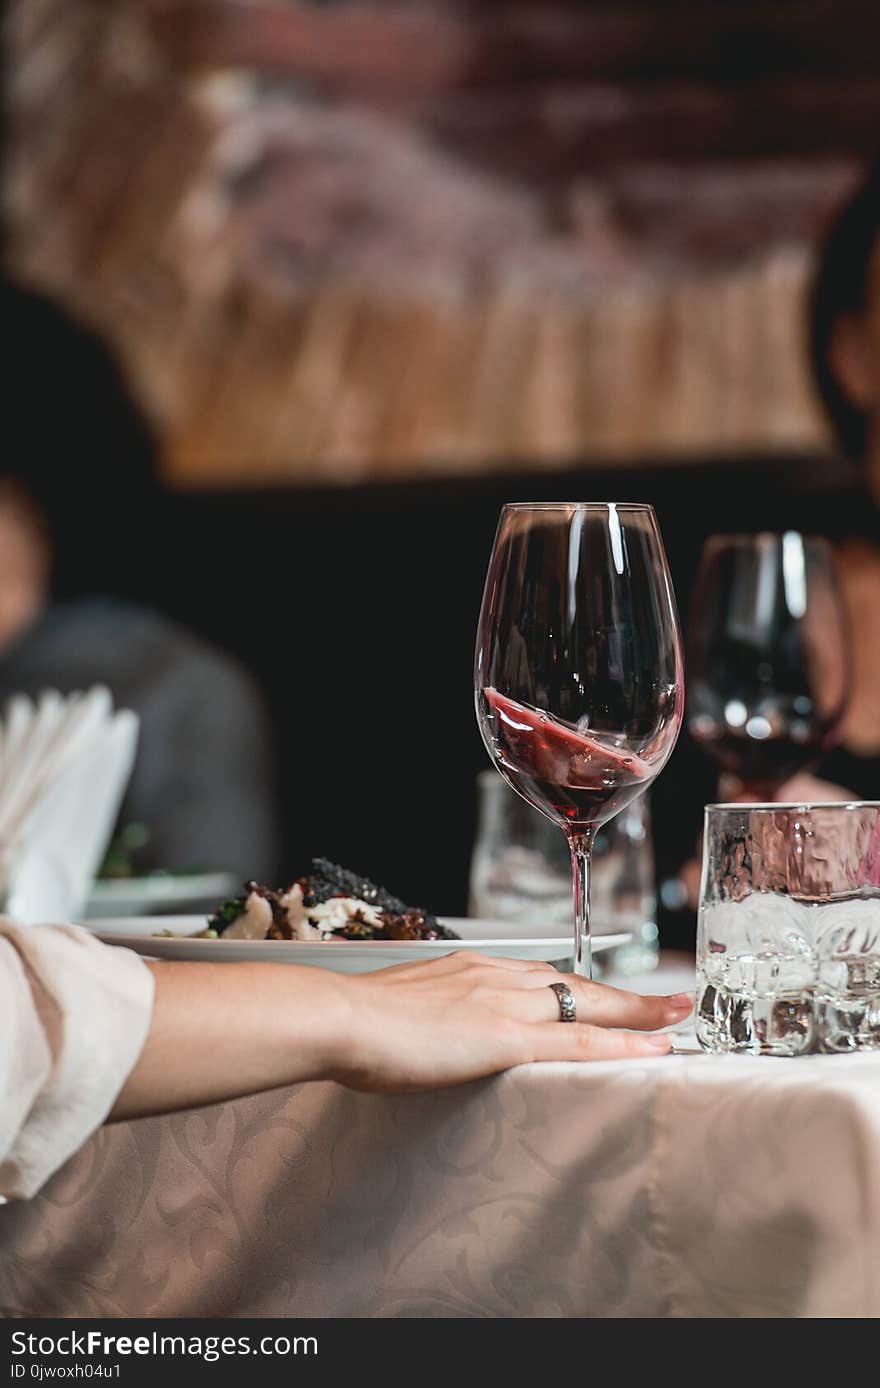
475, 501, 684, 977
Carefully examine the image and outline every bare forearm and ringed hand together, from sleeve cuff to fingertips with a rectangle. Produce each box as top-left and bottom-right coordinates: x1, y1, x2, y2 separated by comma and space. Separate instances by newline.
111, 944, 693, 1119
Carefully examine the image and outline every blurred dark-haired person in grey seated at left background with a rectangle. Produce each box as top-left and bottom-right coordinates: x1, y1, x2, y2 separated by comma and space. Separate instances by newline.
0, 283, 278, 877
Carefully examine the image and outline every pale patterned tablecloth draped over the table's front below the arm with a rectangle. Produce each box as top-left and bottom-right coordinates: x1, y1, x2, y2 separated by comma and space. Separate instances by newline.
0, 960, 880, 1317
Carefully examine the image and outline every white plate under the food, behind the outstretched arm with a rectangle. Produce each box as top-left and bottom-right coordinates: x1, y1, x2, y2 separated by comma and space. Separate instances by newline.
85, 916, 632, 973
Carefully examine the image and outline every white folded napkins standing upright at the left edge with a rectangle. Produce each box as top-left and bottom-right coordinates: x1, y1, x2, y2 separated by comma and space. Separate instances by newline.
0, 686, 137, 923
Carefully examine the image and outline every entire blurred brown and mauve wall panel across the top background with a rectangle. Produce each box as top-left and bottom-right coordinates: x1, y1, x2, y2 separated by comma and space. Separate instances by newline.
4, 0, 880, 486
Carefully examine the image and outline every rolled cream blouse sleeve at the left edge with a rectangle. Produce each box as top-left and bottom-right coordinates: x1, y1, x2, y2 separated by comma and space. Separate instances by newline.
0, 917, 154, 1201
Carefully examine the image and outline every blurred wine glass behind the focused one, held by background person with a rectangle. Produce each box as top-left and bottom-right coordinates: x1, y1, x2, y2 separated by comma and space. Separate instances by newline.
687, 530, 849, 801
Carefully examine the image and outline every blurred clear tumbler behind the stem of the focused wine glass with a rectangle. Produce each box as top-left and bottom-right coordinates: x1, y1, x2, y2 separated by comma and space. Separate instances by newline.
469, 770, 658, 973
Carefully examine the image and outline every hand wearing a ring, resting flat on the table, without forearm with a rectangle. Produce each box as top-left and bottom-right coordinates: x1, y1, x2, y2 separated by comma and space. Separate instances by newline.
333, 949, 693, 1092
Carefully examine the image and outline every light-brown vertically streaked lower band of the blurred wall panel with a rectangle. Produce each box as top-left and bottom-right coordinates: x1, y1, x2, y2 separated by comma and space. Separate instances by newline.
161, 257, 822, 484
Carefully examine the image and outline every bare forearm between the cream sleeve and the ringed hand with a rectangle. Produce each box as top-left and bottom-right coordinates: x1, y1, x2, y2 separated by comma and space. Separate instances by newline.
111, 962, 348, 1119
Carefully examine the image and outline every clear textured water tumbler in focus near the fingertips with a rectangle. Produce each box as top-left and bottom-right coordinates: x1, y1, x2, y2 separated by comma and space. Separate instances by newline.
697, 801, 880, 1056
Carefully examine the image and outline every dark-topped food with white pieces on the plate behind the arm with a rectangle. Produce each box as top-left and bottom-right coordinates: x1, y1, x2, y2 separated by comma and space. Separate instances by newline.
205, 858, 458, 942
